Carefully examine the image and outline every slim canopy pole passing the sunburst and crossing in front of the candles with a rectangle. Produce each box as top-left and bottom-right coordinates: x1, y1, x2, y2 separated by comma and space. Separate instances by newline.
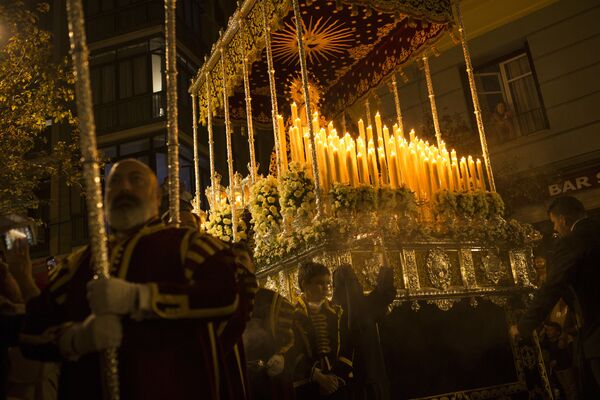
292, 0, 323, 217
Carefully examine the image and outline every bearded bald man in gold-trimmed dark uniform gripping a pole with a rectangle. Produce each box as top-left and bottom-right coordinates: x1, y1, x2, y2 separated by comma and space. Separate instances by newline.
20, 159, 256, 400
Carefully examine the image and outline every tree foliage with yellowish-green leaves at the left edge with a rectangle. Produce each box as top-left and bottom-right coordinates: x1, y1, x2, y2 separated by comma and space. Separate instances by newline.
0, 1, 80, 214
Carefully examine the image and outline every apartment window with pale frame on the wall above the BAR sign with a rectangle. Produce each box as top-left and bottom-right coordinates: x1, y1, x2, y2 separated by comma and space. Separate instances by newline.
475, 52, 548, 143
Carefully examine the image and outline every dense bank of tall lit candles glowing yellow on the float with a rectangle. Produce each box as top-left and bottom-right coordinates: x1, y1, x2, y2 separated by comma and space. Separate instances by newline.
278, 103, 486, 200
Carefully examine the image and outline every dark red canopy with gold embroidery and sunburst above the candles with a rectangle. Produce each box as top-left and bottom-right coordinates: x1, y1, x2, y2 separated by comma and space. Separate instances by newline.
190, 0, 452, 124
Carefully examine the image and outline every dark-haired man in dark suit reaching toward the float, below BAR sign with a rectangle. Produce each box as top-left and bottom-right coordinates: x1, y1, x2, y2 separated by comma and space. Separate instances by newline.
510, 196, 600, 399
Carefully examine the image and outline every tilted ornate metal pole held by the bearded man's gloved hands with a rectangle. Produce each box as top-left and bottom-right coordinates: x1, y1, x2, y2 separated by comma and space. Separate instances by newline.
67, 0, 120, 400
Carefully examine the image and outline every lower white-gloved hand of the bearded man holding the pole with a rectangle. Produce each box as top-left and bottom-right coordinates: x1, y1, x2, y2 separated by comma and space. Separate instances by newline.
58, 314, 123, 361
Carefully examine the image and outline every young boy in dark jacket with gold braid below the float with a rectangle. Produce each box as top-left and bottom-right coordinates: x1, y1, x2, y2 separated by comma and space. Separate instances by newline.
288, 262, 354, 400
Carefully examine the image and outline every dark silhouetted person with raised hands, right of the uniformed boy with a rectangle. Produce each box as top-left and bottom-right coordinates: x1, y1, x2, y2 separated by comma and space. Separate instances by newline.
333, 265, 396, 400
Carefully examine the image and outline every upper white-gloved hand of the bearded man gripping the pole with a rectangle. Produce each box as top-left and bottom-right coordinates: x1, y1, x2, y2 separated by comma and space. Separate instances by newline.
87, 278, 147, 315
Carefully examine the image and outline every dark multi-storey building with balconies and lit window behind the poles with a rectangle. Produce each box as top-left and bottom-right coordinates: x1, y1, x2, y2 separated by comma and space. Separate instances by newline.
33, 0, 235, 256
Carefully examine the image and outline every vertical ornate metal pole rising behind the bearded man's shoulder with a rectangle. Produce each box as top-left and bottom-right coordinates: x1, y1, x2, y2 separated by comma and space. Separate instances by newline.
165, 0, 181, 226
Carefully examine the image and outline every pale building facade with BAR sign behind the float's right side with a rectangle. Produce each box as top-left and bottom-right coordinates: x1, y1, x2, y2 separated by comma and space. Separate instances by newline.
371, 0, 600, 234
